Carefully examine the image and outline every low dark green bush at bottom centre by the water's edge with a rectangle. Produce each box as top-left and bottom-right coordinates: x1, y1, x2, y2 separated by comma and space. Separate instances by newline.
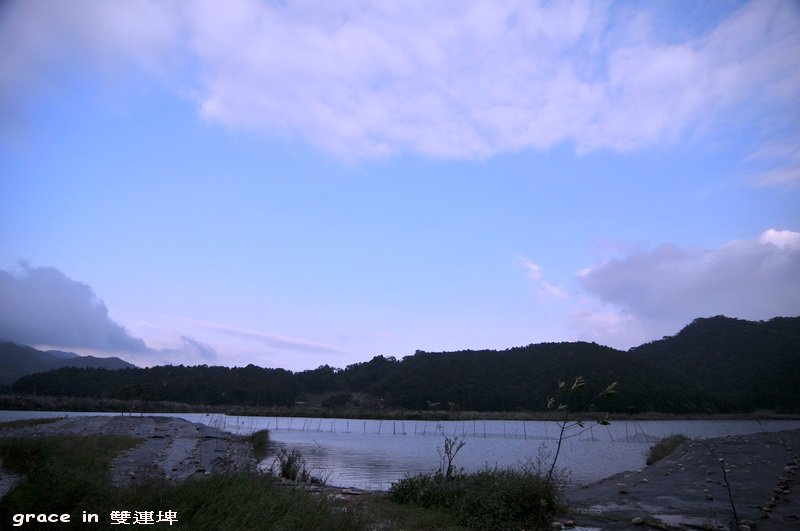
389, 469, 558, 529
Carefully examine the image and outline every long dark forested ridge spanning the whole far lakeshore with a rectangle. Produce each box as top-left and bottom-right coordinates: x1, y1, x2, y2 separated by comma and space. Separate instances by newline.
3, 317, 800, 413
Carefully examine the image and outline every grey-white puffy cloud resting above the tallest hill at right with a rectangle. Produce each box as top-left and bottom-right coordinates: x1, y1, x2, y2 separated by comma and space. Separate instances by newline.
571, 229, 800, 347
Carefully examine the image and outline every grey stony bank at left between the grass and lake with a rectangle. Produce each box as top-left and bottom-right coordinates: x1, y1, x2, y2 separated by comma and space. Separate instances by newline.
0, 416, 256, 490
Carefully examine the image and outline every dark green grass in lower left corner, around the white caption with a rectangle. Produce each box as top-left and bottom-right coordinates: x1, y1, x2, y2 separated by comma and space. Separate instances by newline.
0, 435, 367, 530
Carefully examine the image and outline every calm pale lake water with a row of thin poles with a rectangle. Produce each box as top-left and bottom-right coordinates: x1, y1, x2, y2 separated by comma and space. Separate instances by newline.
0, 411, 800, 490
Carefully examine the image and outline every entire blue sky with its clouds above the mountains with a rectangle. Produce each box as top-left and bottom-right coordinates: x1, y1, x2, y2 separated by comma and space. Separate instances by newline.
0, 0, 800, 371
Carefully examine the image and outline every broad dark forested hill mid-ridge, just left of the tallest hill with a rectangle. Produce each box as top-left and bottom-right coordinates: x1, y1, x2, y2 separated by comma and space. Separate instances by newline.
341, 342, 713, 412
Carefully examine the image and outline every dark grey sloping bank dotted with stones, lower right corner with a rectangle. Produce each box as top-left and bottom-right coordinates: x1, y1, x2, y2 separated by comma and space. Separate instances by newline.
567, 430, 800, 530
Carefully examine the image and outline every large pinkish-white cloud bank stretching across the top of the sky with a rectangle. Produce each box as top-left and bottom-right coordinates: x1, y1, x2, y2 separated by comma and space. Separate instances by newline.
0, 0, 800, 180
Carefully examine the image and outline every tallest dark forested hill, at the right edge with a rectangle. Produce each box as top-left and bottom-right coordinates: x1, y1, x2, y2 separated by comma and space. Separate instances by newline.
629, 315, 800, 411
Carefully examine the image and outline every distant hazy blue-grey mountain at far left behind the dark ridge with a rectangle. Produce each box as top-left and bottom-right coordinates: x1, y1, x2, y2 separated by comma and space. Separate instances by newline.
0, 343, 136, 385
